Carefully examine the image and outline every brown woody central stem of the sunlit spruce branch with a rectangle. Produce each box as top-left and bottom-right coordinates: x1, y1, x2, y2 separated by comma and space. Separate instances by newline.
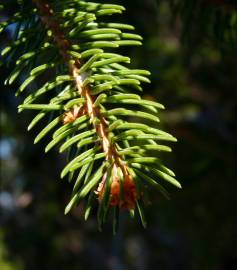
33, 0, 129, 176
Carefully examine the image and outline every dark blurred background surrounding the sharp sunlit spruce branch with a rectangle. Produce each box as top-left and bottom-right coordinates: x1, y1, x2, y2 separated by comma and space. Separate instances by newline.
0, 0, 237, 270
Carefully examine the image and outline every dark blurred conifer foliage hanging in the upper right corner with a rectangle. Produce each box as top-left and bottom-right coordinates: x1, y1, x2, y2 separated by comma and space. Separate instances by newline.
170, 0, 237, 50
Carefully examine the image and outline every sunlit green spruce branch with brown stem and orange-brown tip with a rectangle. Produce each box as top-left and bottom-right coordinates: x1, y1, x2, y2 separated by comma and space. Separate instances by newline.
0, 0, 181, 229
